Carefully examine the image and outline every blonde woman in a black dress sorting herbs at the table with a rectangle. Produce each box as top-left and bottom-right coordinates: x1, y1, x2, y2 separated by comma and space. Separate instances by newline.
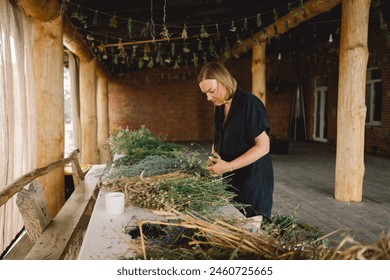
198, 62, 274, 229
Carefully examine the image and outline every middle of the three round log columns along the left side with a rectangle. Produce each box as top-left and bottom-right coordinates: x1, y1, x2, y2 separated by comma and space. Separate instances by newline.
80, 58, 98, 164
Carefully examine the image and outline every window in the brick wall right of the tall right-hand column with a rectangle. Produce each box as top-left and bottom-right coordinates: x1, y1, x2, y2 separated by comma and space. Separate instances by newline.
366, 68, 382, 125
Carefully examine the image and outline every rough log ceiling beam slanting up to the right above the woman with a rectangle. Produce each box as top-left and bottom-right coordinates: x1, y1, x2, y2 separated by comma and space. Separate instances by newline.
221, 0, 341, 59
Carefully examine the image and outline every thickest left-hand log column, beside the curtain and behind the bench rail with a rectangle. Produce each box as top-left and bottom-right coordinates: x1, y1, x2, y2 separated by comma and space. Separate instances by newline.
32, 16, 65, 217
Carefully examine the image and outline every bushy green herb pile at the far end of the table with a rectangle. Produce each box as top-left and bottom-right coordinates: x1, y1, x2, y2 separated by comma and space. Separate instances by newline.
110, 126, 179, 164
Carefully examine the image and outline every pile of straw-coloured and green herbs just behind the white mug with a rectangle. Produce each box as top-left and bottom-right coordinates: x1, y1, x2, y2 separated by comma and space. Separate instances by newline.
102, 172, 240, 213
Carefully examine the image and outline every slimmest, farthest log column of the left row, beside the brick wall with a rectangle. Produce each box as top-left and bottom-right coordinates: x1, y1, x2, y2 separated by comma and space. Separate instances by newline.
97, 71, 110, 163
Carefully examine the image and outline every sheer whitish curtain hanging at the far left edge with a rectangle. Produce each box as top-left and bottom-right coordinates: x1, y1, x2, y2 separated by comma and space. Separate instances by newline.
0, 0, 37, 254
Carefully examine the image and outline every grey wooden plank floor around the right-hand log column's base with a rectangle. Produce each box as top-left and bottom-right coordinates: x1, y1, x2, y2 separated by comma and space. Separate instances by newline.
272, 141, 390, 244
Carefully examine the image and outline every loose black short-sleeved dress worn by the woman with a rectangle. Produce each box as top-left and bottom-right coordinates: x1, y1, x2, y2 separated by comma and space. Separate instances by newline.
214, 87, 274, 218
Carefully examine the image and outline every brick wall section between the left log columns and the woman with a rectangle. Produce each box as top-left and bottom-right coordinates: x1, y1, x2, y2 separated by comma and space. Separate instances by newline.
109, 66, 213, 141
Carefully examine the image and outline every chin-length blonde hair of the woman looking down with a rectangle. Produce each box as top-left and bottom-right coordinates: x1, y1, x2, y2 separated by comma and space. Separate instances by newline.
198, 62, 237, 101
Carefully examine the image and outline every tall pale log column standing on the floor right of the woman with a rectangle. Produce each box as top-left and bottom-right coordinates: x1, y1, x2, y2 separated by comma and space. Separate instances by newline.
335, 0, 370, 201
